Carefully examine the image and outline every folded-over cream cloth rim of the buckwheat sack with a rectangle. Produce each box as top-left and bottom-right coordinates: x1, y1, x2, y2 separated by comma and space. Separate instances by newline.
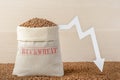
17, 26, 59, 41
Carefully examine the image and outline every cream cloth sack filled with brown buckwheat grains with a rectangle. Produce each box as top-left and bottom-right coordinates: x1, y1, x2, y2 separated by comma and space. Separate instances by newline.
13, 18, 64, 76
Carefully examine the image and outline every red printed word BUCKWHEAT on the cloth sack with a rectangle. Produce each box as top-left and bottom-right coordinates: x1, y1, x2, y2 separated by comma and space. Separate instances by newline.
19, 47, 57, 55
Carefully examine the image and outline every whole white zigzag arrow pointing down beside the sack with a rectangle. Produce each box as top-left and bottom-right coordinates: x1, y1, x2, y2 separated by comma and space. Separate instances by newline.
59, 16, 104, 72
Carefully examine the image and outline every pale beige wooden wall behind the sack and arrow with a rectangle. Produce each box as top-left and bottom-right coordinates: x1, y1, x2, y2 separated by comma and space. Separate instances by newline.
0, 0, 120, 63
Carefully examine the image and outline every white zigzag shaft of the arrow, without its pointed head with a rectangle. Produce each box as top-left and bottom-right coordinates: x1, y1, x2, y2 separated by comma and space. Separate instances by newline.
59, 17, 101, 59
